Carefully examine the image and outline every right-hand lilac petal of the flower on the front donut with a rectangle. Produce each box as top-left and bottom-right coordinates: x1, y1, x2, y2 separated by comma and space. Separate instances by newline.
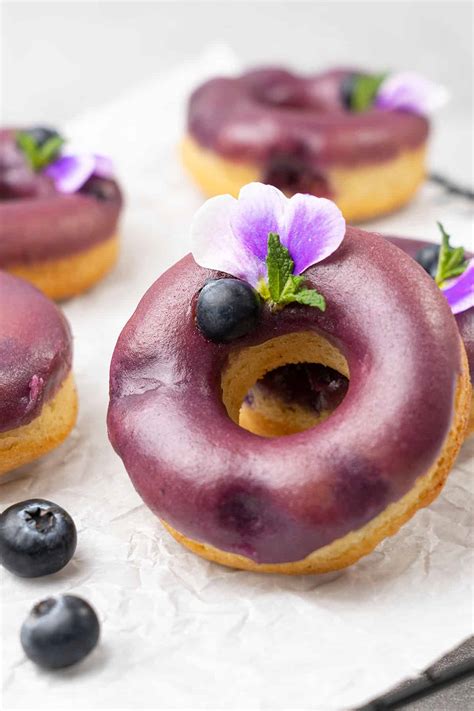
281, 193, 346, 274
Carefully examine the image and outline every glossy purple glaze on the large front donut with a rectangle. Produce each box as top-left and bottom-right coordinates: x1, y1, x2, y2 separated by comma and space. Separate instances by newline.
108, 228, 460, 563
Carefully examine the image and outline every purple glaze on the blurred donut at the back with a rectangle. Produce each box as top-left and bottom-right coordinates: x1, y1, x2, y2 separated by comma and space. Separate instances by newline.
188, 68, 429, 170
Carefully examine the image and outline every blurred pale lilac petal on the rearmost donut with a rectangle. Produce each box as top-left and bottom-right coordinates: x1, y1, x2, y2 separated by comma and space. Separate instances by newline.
375, 72, 449, 116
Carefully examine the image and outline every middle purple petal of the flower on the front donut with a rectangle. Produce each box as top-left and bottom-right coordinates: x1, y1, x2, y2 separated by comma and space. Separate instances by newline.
231, 183, 287, 262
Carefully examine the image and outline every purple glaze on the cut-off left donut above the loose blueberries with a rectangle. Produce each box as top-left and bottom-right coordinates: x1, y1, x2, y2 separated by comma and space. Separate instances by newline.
0, 271, 72, 432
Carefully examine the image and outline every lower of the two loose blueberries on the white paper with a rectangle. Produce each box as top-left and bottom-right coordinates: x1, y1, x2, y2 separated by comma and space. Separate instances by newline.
20, 595, 100, 669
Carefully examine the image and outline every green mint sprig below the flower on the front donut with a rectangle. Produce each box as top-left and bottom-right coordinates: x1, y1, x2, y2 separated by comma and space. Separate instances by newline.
257, 232, 326, 311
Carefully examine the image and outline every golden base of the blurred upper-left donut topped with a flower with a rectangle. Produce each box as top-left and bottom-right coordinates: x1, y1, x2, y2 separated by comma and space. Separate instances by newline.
6, 235, 119, 301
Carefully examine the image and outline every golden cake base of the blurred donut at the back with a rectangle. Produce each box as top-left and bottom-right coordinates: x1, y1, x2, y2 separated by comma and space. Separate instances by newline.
181, 135, 426, 222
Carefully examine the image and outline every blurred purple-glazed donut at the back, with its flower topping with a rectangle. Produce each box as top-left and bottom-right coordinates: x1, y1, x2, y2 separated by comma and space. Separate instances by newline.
181, 68, 445, 222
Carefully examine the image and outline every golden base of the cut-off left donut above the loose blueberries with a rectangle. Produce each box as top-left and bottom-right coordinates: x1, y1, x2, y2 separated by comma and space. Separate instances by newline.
0, 373, 77, 474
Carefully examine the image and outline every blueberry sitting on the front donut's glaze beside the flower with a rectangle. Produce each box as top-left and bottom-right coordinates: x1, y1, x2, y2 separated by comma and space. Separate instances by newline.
196, 279, 260, 343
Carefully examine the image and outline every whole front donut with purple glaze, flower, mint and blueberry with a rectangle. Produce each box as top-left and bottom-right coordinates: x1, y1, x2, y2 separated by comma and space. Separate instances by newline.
108, 184, 471, 574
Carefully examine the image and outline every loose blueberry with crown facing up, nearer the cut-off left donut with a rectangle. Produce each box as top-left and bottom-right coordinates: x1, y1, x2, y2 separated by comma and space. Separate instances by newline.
0, 499, 77, 578
